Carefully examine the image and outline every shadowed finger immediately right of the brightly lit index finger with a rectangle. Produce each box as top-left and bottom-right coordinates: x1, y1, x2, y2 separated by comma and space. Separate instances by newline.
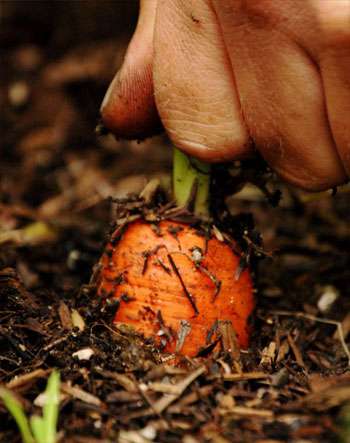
213, 1, 346, 190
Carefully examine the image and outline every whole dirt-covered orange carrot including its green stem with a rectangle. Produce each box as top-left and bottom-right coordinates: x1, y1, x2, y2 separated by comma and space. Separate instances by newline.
98, 150, 254, 356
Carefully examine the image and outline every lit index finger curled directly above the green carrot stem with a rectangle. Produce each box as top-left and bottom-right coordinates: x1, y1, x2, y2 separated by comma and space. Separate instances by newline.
153, 0, 249, 161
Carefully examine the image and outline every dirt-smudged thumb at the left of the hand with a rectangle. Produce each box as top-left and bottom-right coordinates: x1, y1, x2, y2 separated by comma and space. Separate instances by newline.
101, 0, 161, 138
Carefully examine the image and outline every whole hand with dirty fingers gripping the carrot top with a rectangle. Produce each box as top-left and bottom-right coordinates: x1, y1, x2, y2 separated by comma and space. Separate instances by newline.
101, 0, 350, 191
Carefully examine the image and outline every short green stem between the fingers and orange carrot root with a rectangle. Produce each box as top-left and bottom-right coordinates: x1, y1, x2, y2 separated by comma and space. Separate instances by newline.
173, 148, 210, 218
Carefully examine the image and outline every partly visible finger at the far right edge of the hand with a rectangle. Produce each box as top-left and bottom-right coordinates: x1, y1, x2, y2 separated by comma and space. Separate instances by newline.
319, 0, 350, 176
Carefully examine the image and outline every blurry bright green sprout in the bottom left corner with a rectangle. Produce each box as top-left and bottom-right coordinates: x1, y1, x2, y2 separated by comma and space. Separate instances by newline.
0, 371, 60, 443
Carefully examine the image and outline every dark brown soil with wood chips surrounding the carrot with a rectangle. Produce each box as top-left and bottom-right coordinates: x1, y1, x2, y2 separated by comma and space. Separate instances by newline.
0, 0, 350, 443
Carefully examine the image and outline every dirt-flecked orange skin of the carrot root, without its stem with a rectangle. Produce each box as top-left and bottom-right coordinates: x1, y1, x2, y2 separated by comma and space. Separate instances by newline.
98, 220, 255, 356
